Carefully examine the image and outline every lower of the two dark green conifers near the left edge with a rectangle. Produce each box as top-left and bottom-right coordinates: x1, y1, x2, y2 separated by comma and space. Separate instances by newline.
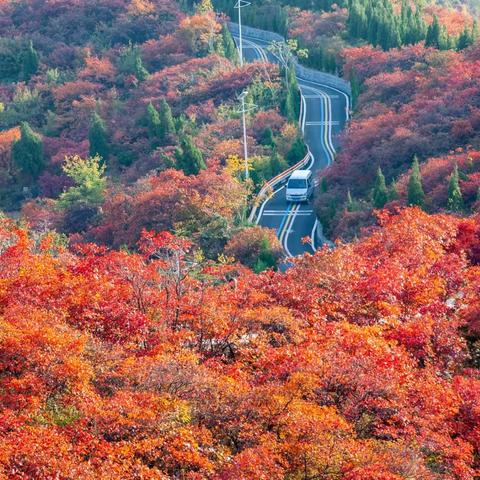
12, 122, 45, 181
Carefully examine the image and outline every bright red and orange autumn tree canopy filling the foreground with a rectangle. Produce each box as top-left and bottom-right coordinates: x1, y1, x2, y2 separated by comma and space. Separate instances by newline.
0, 209, 480, 480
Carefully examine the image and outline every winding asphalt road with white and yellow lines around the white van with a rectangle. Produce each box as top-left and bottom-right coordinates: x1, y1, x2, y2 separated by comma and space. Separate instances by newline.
234, 31, 349, 257
